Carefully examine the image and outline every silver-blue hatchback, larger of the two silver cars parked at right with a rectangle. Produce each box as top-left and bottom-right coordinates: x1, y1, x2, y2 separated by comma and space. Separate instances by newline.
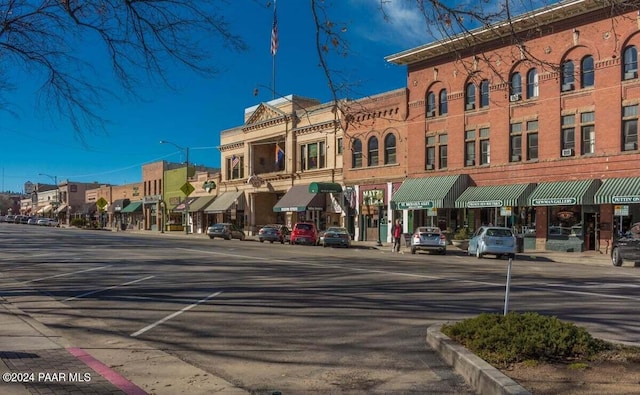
467, 226, 518, 259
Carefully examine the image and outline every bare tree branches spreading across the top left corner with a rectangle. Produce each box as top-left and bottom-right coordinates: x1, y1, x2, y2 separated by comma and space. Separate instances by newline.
0, 0, 245, 140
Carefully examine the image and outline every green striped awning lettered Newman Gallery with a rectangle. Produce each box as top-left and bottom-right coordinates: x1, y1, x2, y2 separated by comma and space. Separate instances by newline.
529, 180, 601, 206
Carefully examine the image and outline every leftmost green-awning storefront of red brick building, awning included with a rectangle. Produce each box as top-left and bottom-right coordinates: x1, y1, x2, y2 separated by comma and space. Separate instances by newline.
391, 174, 469, 238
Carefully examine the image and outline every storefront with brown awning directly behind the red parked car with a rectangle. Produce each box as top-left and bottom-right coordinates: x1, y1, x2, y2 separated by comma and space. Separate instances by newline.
273, 183, 327, 230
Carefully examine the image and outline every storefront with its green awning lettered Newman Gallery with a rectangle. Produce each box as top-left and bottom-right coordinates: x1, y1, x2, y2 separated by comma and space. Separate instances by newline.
529, 180, 601, 252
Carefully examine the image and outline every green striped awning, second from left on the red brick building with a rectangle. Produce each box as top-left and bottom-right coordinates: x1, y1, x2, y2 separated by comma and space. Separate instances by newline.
456, 184, 536, 208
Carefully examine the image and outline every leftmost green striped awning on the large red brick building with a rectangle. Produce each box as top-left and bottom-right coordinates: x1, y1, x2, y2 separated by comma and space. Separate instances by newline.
391, 174, 469, 210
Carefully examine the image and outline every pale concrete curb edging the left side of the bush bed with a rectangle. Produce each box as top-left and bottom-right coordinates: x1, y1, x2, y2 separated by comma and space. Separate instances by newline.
426, 324, 531, 395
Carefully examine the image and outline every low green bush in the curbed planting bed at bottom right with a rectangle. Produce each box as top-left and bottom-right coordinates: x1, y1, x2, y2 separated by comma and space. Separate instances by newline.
442, 313, 611, 366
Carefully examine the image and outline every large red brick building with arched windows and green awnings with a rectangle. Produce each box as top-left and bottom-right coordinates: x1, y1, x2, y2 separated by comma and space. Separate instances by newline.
372, 0, 640, 251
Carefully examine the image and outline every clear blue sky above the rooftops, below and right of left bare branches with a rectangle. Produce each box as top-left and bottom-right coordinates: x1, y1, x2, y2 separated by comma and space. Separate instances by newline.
0, 0, 436, 191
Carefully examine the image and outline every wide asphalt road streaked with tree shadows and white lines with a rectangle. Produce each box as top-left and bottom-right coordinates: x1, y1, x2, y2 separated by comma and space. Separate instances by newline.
0, 224, 640, 393
